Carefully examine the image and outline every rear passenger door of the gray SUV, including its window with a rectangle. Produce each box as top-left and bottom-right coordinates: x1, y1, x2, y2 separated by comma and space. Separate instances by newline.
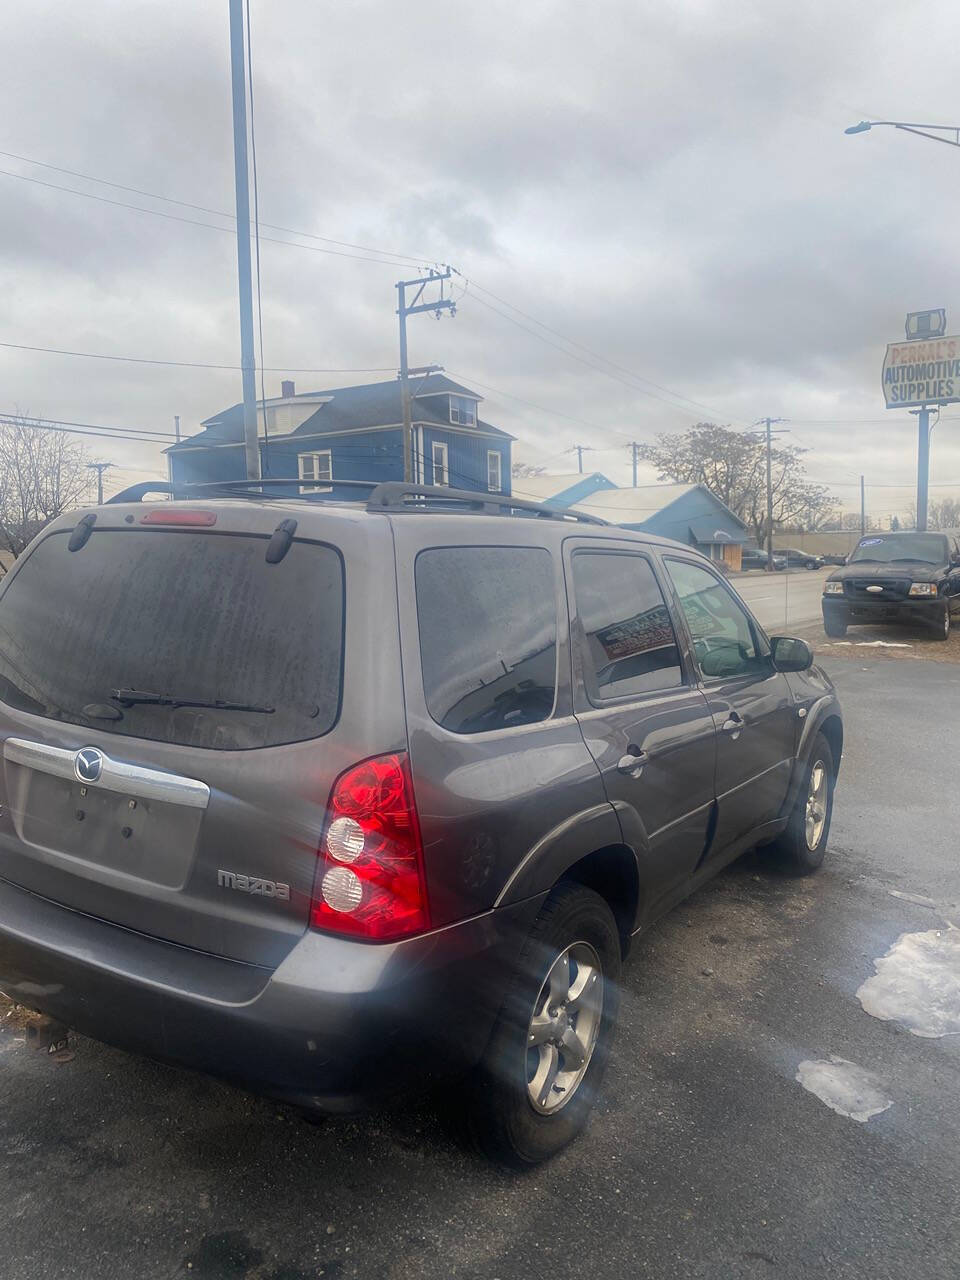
564, 539, 717, 909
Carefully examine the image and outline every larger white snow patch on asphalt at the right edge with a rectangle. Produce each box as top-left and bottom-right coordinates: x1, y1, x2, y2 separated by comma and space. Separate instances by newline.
856, 928, 960, 1039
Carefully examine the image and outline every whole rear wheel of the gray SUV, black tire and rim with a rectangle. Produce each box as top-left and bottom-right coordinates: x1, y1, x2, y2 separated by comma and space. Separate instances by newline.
456, 882, 621, 1169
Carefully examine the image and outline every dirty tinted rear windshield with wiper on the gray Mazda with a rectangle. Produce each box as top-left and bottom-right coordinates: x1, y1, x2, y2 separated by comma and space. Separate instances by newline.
0, 529, 343, 750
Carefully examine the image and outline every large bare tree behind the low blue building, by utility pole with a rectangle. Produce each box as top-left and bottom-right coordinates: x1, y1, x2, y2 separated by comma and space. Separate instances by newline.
640, 422, 836, 541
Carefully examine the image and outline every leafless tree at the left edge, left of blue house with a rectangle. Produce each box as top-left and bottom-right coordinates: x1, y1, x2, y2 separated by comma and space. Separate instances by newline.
0, 412, 90, 559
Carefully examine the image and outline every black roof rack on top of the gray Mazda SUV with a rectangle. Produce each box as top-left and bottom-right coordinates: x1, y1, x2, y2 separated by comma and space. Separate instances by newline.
106, 476, 609, 525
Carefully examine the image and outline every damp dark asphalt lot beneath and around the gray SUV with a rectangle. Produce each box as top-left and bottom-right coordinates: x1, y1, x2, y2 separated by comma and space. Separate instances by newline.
0, 655, 960, 1280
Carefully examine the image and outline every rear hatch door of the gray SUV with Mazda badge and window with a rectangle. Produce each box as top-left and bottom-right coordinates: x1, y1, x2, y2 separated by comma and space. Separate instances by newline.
0, 504, 403, 966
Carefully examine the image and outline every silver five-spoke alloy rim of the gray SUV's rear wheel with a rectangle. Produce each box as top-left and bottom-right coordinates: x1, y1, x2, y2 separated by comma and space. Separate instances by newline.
526, 942, 603, 1115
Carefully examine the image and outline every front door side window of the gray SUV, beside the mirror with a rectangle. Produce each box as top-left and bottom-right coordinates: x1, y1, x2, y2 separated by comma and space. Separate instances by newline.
667, 558, 771, 680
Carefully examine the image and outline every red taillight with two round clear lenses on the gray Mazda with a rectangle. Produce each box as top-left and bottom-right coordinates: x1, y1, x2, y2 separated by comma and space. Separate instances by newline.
310, 753, 429, 942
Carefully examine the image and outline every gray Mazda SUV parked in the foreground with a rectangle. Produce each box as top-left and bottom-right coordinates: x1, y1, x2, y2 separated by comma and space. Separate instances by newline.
0, 481, 842, 1165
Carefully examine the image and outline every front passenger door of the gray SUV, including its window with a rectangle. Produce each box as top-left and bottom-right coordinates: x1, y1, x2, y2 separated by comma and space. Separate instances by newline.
664, 556, 797, 855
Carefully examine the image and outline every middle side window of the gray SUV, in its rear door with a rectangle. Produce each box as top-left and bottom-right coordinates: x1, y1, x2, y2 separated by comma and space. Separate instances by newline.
572, 552, 682, 699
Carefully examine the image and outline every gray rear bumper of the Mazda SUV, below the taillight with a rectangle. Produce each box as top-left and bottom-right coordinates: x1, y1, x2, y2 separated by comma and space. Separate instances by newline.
0, 881, 541, 1111
